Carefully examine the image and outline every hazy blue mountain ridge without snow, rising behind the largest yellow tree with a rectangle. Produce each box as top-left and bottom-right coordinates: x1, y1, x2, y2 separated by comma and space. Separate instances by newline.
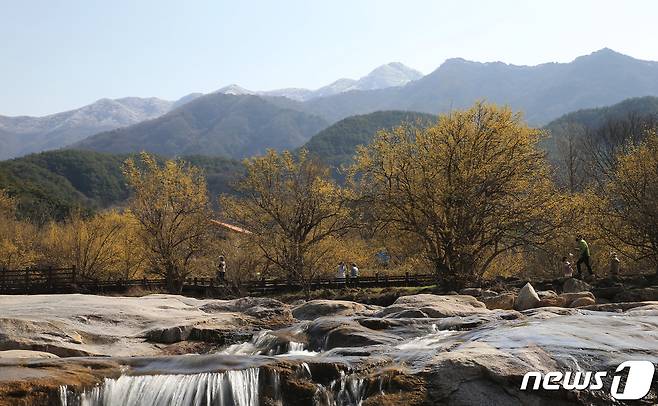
305, 48, 658, 125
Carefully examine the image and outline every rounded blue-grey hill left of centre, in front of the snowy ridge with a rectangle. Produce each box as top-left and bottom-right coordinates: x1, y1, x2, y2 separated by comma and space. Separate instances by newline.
74, 93, 329, 159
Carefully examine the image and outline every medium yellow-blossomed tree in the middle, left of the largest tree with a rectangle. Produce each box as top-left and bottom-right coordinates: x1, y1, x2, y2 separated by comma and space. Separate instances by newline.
220, 150, 353, 292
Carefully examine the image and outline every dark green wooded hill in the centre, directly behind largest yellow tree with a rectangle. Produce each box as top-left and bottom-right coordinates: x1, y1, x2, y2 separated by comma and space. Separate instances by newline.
304, 111, 436, 168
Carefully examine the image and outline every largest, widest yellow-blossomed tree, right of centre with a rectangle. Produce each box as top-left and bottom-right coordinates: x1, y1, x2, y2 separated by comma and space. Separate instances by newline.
351, 103, 559, 285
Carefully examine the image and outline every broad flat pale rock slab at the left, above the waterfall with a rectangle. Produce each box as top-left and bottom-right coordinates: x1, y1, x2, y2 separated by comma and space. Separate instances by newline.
0, 294, 270, 357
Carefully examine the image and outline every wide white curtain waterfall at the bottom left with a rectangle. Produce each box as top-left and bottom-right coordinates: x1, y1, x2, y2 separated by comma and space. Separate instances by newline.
60, 368, 259, 406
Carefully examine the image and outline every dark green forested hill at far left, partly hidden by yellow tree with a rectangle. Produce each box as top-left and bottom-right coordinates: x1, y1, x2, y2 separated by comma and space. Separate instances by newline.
0, 150, 242, 222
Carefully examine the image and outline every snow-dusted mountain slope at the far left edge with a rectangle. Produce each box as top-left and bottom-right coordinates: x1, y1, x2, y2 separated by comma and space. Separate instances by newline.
0, 94, 200, 160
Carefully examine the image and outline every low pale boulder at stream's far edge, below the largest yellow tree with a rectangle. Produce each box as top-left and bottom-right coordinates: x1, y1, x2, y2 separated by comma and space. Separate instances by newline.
375, 293, 489, 318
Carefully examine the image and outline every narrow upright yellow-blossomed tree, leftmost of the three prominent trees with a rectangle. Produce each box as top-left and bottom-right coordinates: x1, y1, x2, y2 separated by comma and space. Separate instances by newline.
124, 153, 211, 292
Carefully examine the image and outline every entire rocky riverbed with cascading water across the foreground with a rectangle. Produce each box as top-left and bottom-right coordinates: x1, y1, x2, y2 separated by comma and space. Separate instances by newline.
0, 280, 658, 406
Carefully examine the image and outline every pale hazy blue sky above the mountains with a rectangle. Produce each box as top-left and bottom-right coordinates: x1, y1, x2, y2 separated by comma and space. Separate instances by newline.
0, 0, 658, 115
